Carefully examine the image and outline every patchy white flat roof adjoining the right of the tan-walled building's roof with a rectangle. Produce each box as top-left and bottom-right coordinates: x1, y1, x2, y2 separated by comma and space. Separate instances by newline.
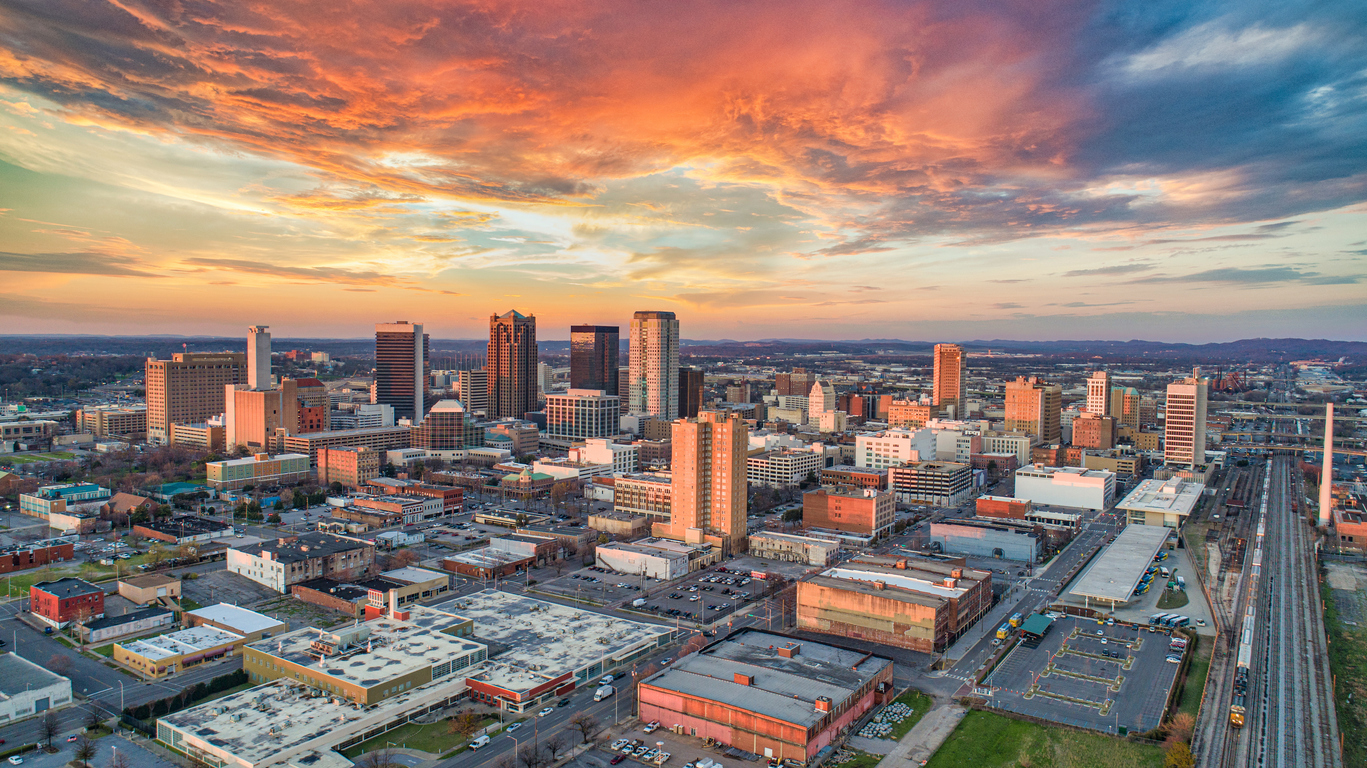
439, 589, 673, 691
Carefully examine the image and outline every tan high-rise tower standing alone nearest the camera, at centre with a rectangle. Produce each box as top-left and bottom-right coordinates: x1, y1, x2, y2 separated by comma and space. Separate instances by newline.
655, 411, 749, 553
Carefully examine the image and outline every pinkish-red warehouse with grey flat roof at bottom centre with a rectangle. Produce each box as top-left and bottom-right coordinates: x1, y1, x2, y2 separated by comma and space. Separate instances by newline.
637, 629, 894, 763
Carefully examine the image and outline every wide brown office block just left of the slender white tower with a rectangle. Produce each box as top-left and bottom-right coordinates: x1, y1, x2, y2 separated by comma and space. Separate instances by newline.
145, 353, 247, 445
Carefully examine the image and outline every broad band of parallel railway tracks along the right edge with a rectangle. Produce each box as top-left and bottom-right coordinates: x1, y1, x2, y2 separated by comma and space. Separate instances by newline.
1234, 456, 1342, 768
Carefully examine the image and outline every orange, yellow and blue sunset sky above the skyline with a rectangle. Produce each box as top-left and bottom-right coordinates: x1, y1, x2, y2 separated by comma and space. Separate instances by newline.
0, 0, 1367, 342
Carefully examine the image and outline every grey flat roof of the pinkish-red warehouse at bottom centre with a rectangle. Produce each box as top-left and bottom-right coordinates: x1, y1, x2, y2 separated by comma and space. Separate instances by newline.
642, 630, 893, 727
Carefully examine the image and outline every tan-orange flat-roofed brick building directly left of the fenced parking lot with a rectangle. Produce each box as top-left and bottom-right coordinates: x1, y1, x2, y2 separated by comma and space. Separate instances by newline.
797, 556, 992, 653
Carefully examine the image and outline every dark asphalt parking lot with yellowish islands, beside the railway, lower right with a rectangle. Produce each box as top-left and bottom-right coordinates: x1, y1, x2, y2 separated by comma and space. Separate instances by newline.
983, 616, 1180, 732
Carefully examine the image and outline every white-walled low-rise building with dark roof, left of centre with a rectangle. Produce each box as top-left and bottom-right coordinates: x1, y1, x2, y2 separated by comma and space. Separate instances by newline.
227, 533, 375, 594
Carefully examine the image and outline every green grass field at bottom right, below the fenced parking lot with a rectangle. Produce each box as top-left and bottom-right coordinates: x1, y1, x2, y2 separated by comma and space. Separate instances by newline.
927, 711, 1163, 768
